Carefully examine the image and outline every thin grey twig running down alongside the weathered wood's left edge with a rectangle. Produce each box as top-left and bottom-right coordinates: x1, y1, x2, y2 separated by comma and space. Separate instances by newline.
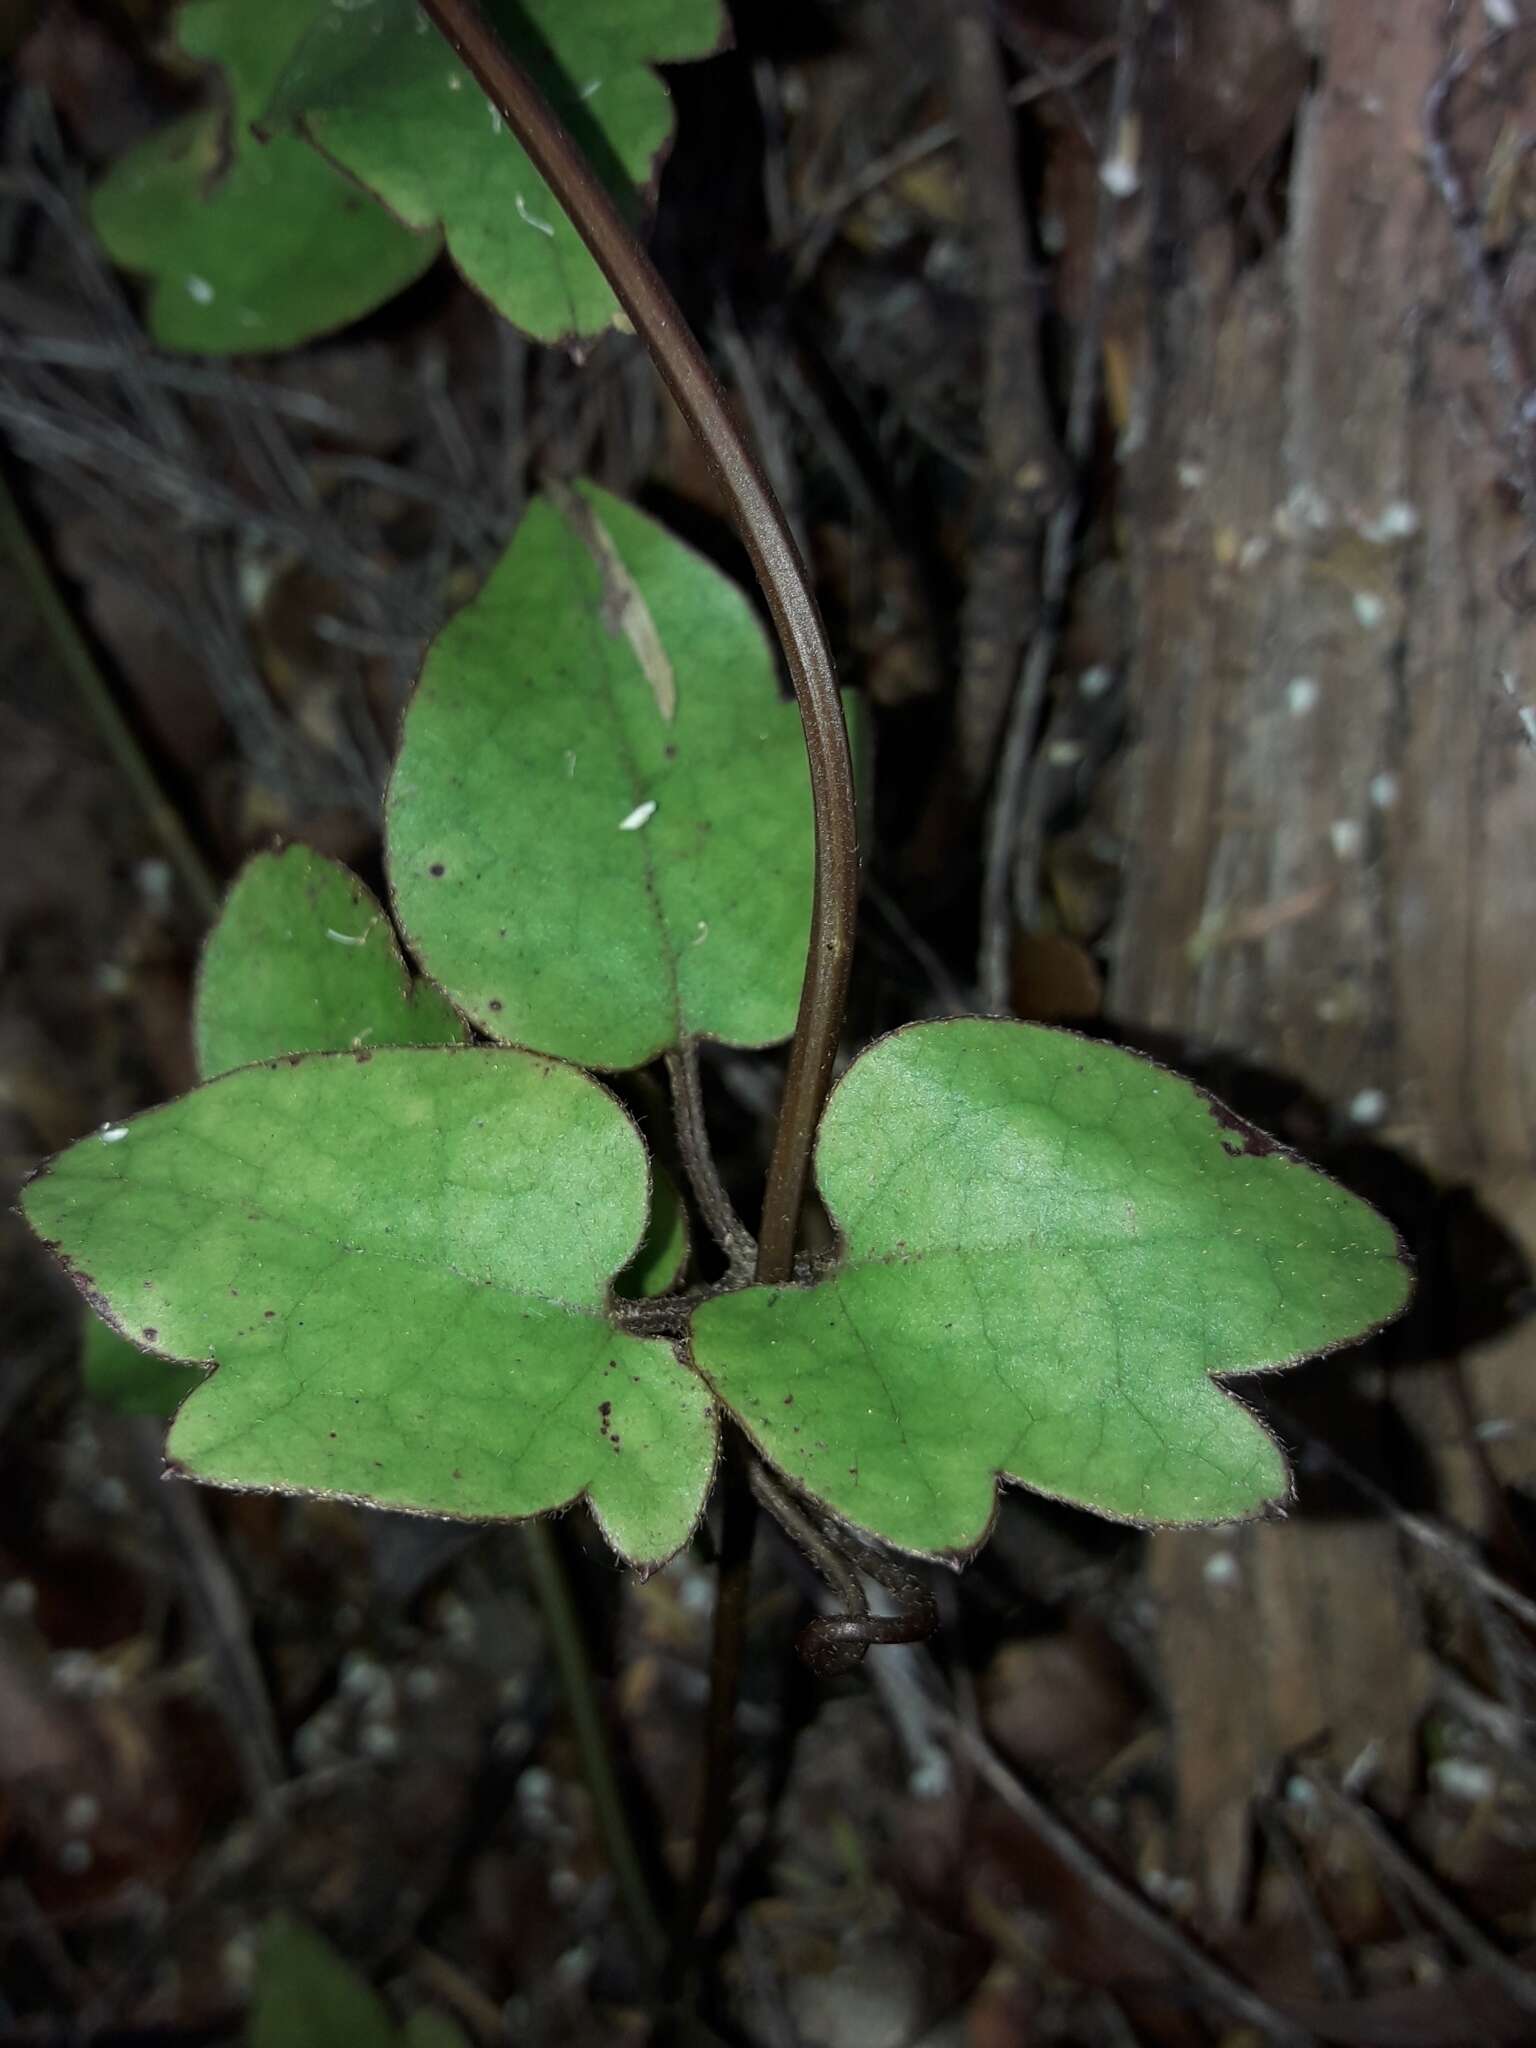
977, 0, 1139, 1014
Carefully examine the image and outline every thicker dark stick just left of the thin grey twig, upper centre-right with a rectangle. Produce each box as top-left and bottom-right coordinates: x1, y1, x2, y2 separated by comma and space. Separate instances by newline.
950, 0, 1069, 795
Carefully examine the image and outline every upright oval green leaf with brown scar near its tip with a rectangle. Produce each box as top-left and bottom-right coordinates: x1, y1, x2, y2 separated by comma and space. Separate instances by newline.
385, 485, 856, 1067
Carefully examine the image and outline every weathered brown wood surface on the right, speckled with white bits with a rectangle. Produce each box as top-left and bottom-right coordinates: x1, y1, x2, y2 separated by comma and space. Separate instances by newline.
1112, 0, 1536, 1913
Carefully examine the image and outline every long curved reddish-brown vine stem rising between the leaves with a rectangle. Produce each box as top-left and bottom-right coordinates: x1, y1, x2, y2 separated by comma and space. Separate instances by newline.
424, 0, 858, 1980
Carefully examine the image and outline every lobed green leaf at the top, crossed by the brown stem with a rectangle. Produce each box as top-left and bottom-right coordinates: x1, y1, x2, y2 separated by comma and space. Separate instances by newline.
264, 0, 725, 342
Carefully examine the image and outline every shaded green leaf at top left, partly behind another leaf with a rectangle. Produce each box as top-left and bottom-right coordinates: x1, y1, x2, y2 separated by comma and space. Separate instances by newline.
90, 0, 440, 354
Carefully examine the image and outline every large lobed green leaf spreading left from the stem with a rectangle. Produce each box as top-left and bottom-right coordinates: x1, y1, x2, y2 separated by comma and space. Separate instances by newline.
25, 1047, 715, 1567
